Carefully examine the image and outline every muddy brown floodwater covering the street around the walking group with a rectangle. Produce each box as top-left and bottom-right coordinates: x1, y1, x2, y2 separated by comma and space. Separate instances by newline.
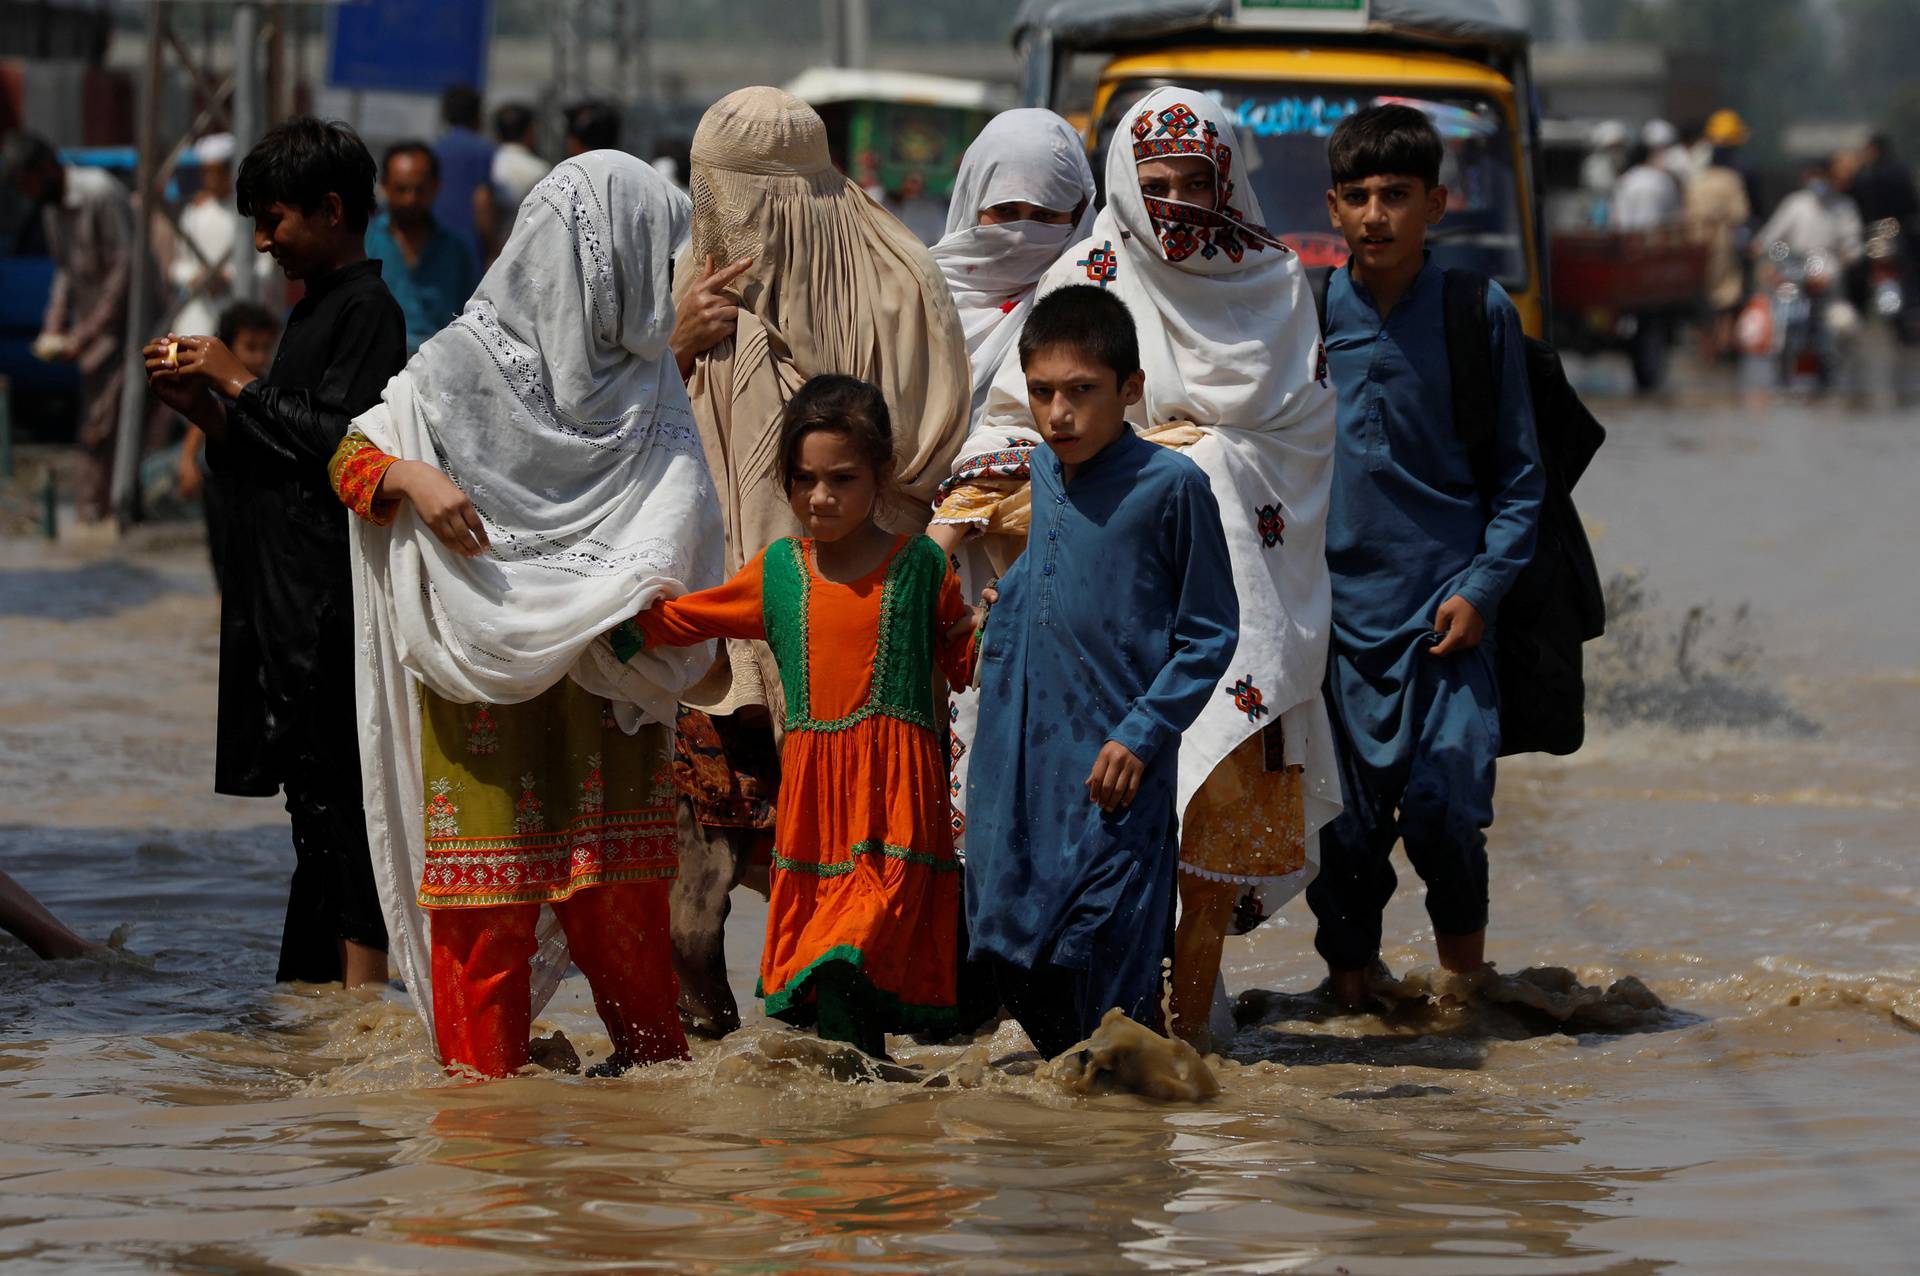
0, 399, 1920, 1274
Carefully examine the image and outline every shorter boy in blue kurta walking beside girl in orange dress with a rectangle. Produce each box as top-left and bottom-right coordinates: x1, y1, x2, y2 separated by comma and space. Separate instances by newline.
966, 286, 1240, 1057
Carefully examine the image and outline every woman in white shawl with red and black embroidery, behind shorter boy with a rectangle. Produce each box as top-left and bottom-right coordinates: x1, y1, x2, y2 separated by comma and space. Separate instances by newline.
948, 88, 1340, 1046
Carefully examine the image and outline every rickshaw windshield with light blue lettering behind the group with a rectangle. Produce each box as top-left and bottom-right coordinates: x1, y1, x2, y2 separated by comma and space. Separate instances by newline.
1094, 79, 1528, 292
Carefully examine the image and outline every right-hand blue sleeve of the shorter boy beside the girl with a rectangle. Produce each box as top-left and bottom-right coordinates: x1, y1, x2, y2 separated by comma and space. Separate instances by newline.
1108, 470, 1240, 764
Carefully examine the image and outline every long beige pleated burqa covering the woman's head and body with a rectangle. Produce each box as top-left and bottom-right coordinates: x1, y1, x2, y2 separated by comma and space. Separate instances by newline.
674, 88, 972, 714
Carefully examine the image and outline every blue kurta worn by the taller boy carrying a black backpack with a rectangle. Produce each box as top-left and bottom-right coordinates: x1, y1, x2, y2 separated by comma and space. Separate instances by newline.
1327, 263, 1546, 782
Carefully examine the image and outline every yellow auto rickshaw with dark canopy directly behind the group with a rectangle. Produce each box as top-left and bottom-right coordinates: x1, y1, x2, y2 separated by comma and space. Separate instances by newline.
1014, 0, 1548, 336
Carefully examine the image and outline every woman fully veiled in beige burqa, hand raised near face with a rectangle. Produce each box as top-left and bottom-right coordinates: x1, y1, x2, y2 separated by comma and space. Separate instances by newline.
672, 88, 972, 1036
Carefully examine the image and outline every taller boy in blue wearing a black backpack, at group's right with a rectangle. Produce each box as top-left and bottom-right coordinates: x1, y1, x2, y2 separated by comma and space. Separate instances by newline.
1308, 106, 1546, 1007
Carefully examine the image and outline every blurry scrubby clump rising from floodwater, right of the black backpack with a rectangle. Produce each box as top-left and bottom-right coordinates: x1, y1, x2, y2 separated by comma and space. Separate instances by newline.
1586, 572, 1820, 737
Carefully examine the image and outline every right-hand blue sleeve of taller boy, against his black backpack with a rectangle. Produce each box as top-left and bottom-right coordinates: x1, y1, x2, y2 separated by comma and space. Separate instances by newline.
1455, 284, 1546, 622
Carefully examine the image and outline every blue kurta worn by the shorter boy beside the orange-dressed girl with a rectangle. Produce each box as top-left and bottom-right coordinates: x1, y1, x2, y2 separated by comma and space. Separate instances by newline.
966, 432, 1240, 1030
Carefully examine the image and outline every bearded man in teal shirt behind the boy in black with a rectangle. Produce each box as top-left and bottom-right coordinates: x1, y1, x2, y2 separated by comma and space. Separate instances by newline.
367, 142, 480, 355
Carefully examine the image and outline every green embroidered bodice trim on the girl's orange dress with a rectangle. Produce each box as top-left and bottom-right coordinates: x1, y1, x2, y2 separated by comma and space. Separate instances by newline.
760, 535, 947, 733
